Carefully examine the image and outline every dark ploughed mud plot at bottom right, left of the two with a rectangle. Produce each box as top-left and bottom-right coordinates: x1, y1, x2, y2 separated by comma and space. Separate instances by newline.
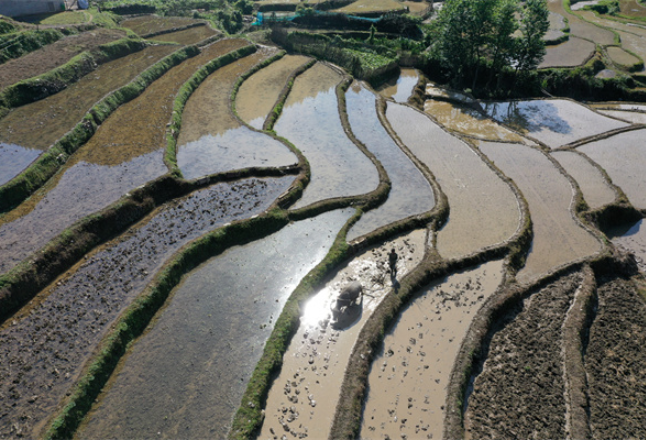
465, 274, 582, 439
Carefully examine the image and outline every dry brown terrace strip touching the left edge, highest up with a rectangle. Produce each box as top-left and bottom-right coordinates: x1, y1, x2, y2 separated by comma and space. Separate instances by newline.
0, 28, 126, 90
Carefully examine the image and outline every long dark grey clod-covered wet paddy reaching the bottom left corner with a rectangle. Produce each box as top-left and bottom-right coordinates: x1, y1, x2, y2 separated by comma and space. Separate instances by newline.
0, 177, 293, 438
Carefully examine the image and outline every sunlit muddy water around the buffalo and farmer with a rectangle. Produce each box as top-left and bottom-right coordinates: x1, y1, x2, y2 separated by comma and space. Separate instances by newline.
258, 231, 426, 439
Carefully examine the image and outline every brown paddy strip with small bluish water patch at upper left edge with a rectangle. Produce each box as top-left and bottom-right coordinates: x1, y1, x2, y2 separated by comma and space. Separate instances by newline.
0, 46, 176, 184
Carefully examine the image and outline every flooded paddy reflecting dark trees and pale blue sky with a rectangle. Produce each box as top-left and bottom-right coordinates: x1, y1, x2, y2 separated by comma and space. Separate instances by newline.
485, 99, 628, 148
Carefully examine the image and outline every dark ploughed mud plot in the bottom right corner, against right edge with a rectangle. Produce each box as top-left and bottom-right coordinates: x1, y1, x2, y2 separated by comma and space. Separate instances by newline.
584, 279, 646, 439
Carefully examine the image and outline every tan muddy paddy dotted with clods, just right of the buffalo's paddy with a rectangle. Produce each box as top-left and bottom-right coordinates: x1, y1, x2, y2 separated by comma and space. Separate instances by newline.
360, 261, 502, 439
